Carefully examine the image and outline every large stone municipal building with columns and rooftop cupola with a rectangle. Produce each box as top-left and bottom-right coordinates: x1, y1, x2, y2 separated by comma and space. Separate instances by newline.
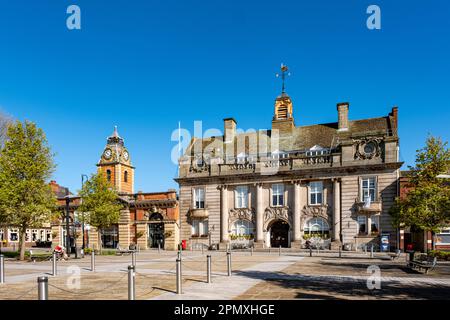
176, 75, 402, 250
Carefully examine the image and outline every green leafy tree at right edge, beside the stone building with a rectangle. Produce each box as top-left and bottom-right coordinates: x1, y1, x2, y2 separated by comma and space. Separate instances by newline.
391, 136, 450, 247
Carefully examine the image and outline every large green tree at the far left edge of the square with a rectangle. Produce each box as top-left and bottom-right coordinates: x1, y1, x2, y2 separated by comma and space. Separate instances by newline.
0, 121, 56, 260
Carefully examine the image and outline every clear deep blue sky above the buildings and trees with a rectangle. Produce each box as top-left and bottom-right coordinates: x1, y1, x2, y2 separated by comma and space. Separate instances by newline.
0, 0, 450, 192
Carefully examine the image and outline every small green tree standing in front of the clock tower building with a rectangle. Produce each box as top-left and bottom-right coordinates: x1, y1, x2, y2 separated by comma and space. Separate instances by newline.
79, 172, 123, 250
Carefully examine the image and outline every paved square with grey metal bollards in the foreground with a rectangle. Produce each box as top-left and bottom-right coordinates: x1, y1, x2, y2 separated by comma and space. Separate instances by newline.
0, 251, 450, 300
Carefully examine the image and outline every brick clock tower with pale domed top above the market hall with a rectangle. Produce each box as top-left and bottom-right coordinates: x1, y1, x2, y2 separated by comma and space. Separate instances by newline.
97, 127, 135, 194
